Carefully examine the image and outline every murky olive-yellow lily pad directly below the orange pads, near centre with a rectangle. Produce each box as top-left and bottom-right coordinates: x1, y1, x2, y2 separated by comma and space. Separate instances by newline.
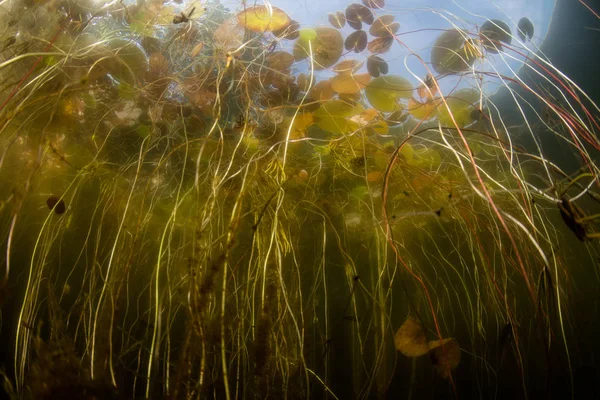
314, 100, 364, 134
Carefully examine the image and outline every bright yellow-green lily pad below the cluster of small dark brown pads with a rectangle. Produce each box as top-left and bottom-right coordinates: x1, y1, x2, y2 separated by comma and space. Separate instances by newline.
365, 75, 413, 112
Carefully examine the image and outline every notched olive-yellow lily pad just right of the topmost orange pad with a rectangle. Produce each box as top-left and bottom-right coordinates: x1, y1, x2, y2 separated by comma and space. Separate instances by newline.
293, 26, 344, 69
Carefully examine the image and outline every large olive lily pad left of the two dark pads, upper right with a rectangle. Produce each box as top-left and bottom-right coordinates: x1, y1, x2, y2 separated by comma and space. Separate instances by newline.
431, 29, 478, 74
